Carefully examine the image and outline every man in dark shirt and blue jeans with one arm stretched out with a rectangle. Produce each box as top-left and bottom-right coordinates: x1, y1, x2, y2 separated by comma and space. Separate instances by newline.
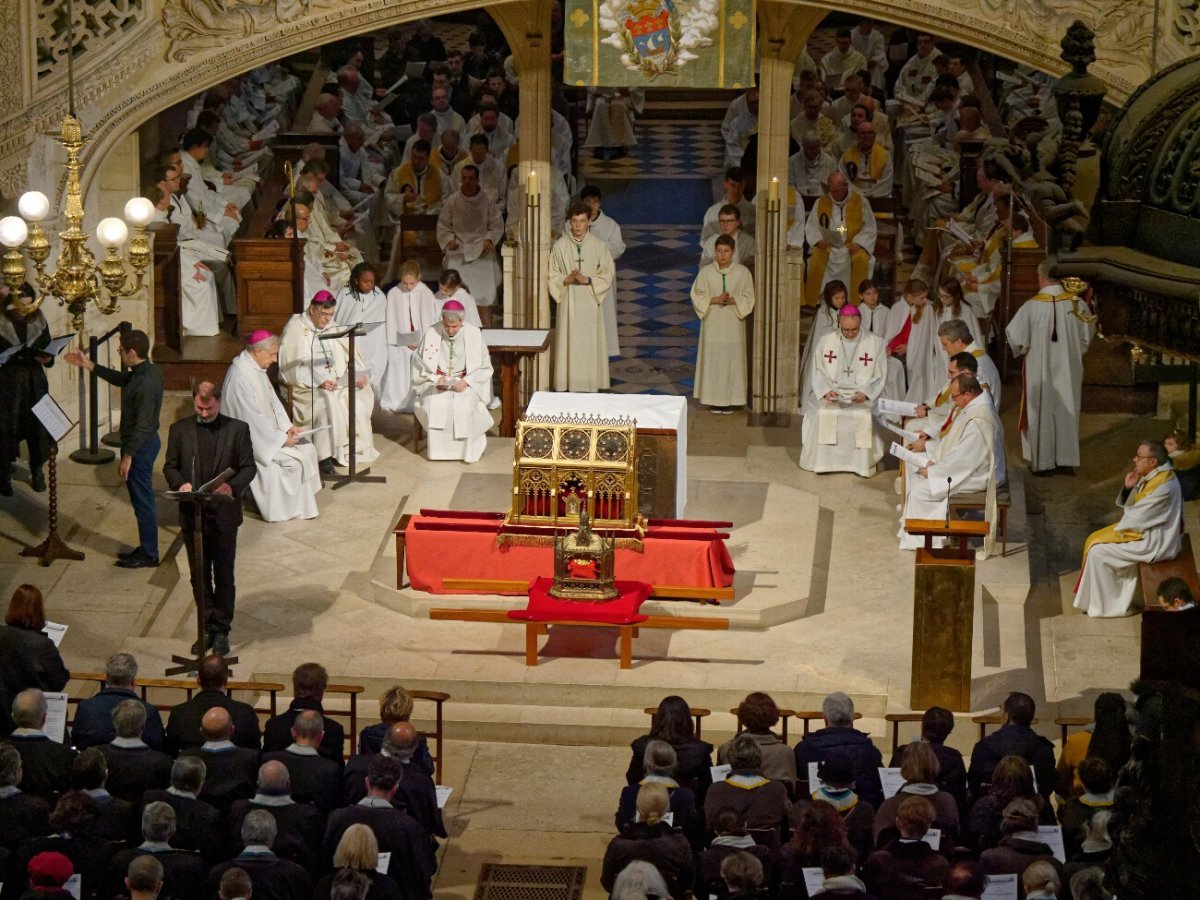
62, 329, 162, 569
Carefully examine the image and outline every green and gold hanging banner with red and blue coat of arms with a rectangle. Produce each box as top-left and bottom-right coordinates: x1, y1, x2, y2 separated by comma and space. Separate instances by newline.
563, 0, 755, 88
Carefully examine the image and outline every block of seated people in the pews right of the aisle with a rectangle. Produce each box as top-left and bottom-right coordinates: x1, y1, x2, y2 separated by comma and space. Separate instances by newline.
604, 692, 1133, 900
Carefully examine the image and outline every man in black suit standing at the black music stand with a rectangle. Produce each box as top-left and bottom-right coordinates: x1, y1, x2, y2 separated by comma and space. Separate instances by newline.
162, 382, 258, 656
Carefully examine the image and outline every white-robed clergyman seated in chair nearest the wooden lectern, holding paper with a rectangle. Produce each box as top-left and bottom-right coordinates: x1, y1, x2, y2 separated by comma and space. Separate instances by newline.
899, 374, 1003, 556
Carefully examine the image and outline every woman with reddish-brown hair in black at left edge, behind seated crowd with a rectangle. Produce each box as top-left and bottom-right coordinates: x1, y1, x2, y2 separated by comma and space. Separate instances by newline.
0, 584, 71, 734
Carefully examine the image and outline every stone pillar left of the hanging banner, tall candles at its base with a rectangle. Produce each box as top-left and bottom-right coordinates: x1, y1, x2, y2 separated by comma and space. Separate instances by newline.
488, 0, 553, 403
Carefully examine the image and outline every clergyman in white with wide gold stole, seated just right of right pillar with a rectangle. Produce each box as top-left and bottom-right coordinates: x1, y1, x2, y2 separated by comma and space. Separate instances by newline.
804, 172, 877, 306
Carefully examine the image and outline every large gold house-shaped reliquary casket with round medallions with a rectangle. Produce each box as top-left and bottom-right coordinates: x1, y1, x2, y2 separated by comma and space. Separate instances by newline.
508, 415, 644, 532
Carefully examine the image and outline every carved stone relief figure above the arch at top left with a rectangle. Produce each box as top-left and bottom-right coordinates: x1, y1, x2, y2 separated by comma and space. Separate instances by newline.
162, 0, 332, 62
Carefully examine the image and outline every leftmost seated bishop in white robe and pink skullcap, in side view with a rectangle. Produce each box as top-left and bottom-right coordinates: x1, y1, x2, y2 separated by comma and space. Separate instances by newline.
221, 329, 320, 522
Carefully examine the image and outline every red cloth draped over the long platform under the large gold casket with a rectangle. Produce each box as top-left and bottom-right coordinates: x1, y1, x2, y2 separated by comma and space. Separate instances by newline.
404, 510, 734, 595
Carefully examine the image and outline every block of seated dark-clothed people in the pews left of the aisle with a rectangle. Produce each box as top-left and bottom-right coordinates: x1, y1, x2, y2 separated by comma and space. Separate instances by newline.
0, 653, 446, 900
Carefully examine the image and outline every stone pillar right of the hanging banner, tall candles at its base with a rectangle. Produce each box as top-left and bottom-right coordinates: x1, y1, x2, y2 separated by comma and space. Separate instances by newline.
750, 0, 826, 426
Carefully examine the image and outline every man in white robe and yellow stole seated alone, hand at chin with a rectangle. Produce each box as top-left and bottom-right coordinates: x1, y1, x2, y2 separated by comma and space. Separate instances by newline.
1075, 440, 1183, 618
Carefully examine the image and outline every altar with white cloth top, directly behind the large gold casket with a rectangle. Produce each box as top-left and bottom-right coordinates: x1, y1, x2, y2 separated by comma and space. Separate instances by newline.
526, 391, 688, 518
